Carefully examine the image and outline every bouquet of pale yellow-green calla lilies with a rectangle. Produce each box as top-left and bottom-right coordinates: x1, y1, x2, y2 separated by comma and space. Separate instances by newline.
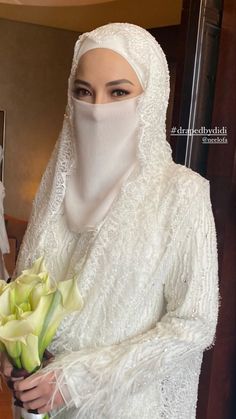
0, 257, 83, 419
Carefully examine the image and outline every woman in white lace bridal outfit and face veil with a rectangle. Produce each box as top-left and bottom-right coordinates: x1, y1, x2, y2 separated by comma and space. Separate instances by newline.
2, 23, 218, 419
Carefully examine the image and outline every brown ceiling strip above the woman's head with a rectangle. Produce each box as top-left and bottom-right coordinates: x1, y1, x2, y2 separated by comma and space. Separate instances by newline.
0, 0, 182, 32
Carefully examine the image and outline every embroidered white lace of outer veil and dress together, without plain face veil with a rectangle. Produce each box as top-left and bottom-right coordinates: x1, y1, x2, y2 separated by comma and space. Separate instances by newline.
16, 23, 218, 419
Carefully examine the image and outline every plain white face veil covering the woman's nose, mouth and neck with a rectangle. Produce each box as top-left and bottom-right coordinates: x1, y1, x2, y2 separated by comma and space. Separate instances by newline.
64, 92, 139, 232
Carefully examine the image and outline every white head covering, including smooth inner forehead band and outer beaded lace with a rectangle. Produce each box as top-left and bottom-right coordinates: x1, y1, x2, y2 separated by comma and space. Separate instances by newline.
16, 23, 173, 278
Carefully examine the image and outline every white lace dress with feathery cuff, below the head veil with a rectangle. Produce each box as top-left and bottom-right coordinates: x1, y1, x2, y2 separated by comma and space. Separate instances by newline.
35, 165, 218, 419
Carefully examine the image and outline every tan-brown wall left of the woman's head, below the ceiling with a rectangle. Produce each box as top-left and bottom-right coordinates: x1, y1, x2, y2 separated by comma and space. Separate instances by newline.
0, 19, 78, 220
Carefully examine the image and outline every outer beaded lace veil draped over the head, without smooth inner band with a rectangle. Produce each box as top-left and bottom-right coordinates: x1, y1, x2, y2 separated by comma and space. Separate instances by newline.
16, 23, 173, 278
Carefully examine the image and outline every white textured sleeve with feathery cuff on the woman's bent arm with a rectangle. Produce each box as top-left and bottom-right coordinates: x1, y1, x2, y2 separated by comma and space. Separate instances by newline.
43, 182, 218, 417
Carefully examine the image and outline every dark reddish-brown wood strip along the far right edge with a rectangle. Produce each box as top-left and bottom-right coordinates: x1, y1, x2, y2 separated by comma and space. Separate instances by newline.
198, 0, 236, 419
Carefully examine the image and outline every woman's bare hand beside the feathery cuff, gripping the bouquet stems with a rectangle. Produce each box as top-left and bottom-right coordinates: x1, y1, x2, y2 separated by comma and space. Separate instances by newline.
14, 371, 65, 413
